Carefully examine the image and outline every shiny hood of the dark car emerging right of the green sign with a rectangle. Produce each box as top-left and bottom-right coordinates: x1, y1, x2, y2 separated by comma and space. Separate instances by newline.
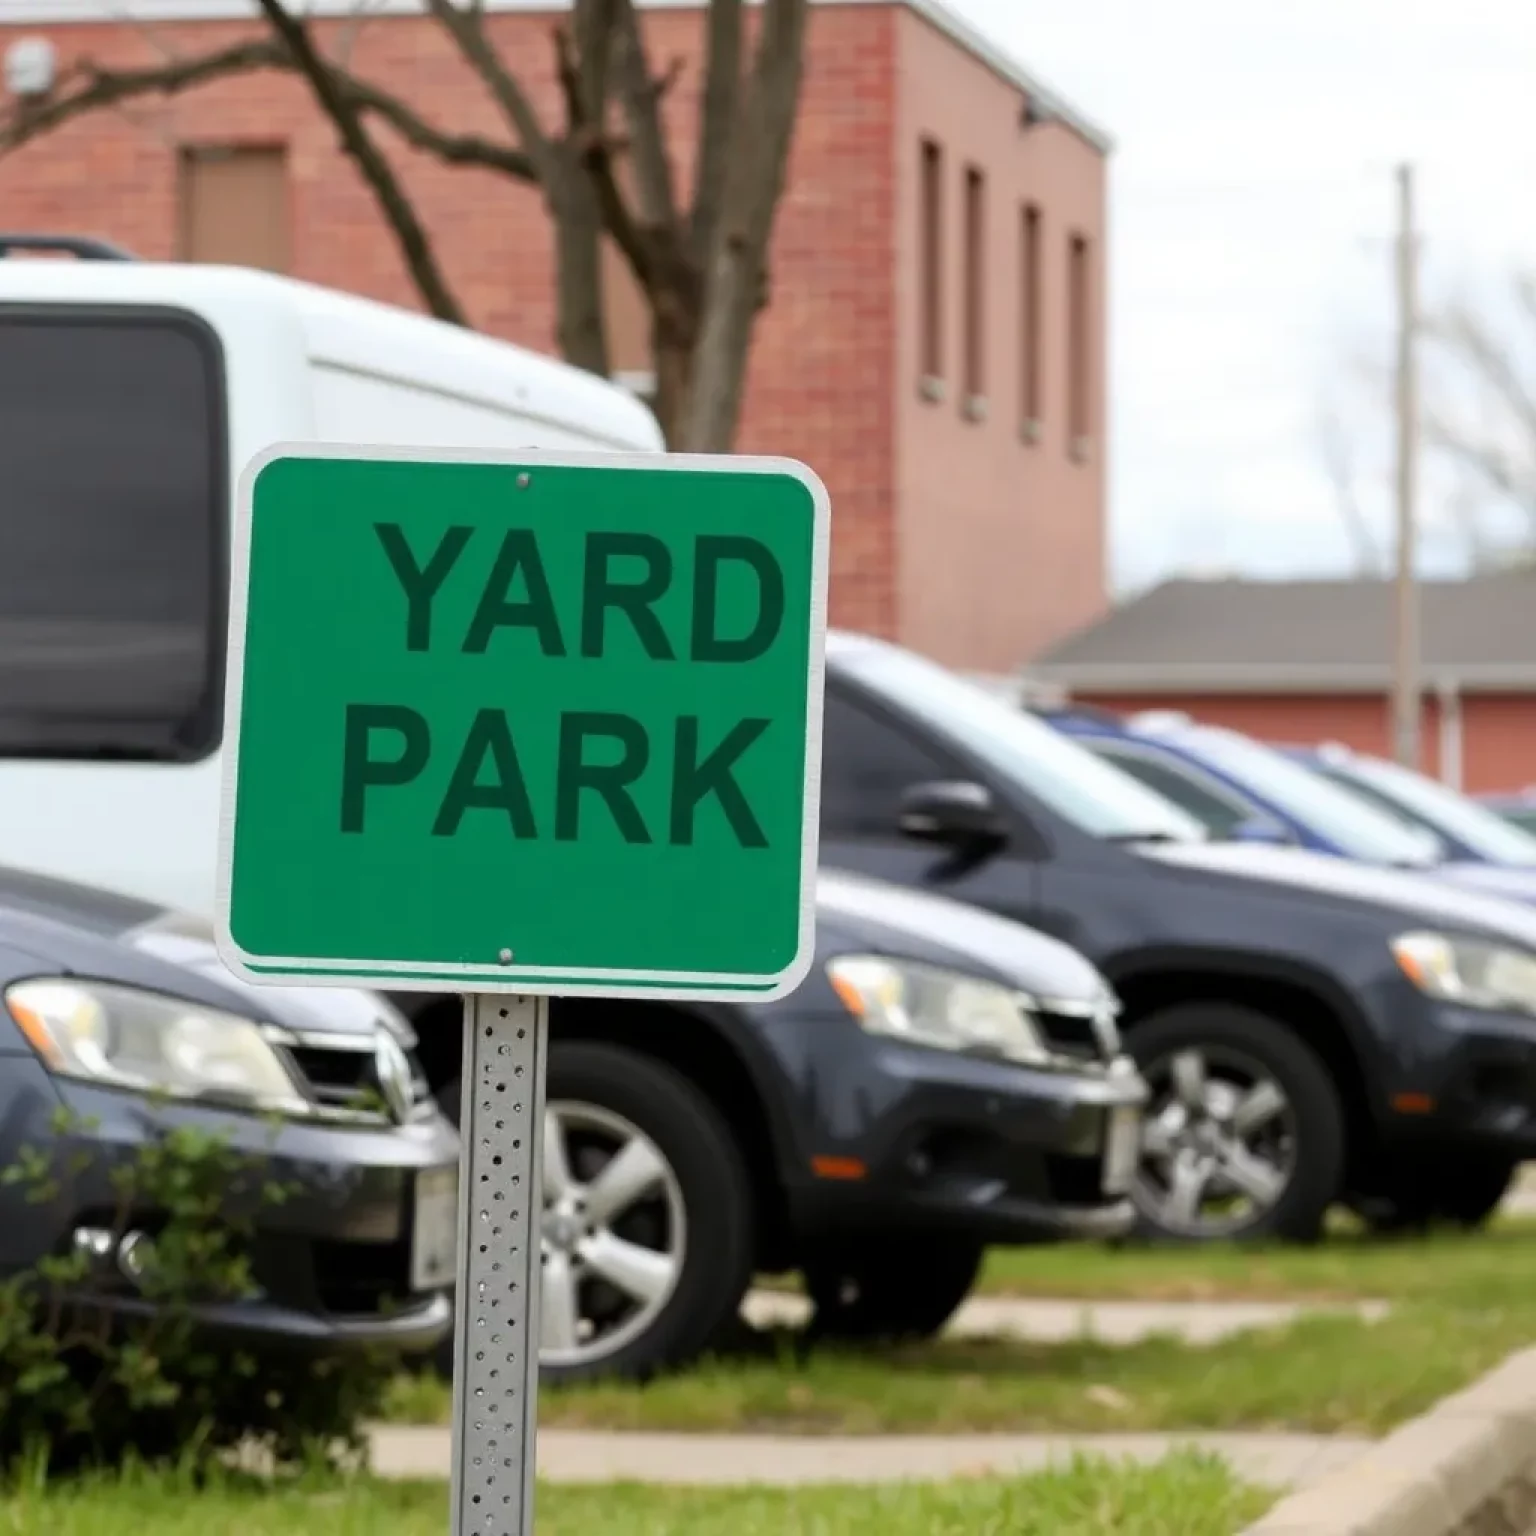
816, 869, 1107, 1003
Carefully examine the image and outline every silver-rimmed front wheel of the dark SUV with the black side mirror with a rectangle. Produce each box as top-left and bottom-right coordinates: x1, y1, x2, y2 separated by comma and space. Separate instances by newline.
1126, 1003, 1346, 1243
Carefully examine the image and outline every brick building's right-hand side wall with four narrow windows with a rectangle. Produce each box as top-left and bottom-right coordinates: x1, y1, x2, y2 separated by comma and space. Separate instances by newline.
892, 11, 1107, 673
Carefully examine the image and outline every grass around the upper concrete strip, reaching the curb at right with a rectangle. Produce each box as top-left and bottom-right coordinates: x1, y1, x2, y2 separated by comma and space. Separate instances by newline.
380, 1226, 1536, 1437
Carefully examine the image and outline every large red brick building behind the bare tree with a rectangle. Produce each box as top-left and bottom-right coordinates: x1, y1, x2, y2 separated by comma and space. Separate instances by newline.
0, 0, 1109, 671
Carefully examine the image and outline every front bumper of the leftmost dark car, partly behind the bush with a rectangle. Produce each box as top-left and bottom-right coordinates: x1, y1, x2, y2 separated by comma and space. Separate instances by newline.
12, 1083, 458, 1353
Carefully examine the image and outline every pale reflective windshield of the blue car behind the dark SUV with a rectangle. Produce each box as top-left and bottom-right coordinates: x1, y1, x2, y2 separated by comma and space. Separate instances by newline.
1150, 727, 1441, 868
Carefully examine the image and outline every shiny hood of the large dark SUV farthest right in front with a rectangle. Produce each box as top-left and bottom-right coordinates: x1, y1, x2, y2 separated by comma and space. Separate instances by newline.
1137, 843, 1536, 949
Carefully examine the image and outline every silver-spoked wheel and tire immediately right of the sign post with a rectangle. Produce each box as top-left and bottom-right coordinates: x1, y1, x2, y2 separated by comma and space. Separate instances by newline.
439, 1041, 753, 1385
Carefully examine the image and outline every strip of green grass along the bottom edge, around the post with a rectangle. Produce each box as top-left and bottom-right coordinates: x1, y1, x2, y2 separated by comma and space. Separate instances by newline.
0, 1453, 1272, 1536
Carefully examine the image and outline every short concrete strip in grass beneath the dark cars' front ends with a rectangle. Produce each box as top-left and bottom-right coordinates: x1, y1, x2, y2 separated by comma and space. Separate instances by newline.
742, 1290, 1387, 1344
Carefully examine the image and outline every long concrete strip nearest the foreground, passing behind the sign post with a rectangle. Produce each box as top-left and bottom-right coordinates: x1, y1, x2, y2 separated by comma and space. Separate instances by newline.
372, 1425, 1370, 1488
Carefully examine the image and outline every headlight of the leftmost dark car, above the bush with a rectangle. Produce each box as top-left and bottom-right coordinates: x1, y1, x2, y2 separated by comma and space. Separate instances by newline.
5, 977, 313, 1115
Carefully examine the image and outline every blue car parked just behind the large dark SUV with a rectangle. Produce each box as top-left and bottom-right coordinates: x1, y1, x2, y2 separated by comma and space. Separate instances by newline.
1043, 708, 1536, 902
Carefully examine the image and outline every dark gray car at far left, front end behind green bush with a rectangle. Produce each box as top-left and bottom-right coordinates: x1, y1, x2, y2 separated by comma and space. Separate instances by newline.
0, 869, 458, 1352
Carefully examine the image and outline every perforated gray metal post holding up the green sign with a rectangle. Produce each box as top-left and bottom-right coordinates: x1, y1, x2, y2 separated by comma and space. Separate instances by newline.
449, 994, 550, 1536
